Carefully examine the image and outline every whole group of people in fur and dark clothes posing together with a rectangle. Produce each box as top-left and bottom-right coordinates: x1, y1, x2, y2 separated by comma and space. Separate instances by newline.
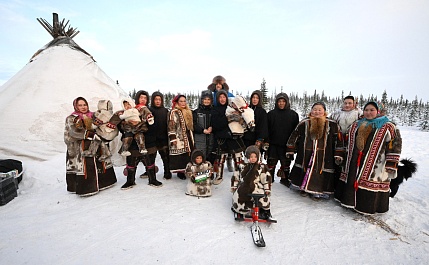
64, 76, 402, 218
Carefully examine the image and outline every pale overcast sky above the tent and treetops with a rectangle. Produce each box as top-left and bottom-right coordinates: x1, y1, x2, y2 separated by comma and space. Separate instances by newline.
0, 0, 429, 101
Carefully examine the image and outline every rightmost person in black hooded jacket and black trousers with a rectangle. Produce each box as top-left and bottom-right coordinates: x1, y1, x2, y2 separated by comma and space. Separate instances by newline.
267, 93, 299, 187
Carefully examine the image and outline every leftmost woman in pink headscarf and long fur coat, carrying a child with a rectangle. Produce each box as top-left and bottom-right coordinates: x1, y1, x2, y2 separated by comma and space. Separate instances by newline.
64, 97, 117, 196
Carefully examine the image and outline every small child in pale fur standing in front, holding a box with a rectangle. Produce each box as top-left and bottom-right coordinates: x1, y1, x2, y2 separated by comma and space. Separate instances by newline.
185, 149, 213, 197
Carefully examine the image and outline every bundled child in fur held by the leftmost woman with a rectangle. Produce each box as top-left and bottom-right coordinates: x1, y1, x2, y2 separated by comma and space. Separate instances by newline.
82, 99, 119, 161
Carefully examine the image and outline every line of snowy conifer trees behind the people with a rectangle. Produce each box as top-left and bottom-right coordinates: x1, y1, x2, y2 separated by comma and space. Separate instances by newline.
129, 79, 429, 131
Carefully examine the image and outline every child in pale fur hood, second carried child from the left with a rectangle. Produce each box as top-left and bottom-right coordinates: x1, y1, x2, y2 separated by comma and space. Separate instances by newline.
119, 99, 154, 156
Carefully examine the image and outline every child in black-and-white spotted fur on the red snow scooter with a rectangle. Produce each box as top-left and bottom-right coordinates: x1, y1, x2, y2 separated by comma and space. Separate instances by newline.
231, 145, 272, 219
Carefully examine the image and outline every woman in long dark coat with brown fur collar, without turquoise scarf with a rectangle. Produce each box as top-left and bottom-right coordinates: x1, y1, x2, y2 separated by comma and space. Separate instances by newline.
286, 102, 343, 200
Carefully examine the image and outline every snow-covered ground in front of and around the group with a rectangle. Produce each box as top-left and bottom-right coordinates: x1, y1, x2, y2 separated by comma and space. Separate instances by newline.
0, 127, 429, 264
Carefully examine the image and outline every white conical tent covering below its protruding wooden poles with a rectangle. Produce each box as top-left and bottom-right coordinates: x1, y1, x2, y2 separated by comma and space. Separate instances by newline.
0, 16, 127, 161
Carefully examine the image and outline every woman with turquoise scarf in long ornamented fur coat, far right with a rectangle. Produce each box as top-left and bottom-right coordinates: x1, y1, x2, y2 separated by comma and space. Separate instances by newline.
335, 101, 402, 214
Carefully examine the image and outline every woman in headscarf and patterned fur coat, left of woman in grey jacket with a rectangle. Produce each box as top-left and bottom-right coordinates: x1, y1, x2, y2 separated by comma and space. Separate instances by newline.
168, 94, 195, 179
